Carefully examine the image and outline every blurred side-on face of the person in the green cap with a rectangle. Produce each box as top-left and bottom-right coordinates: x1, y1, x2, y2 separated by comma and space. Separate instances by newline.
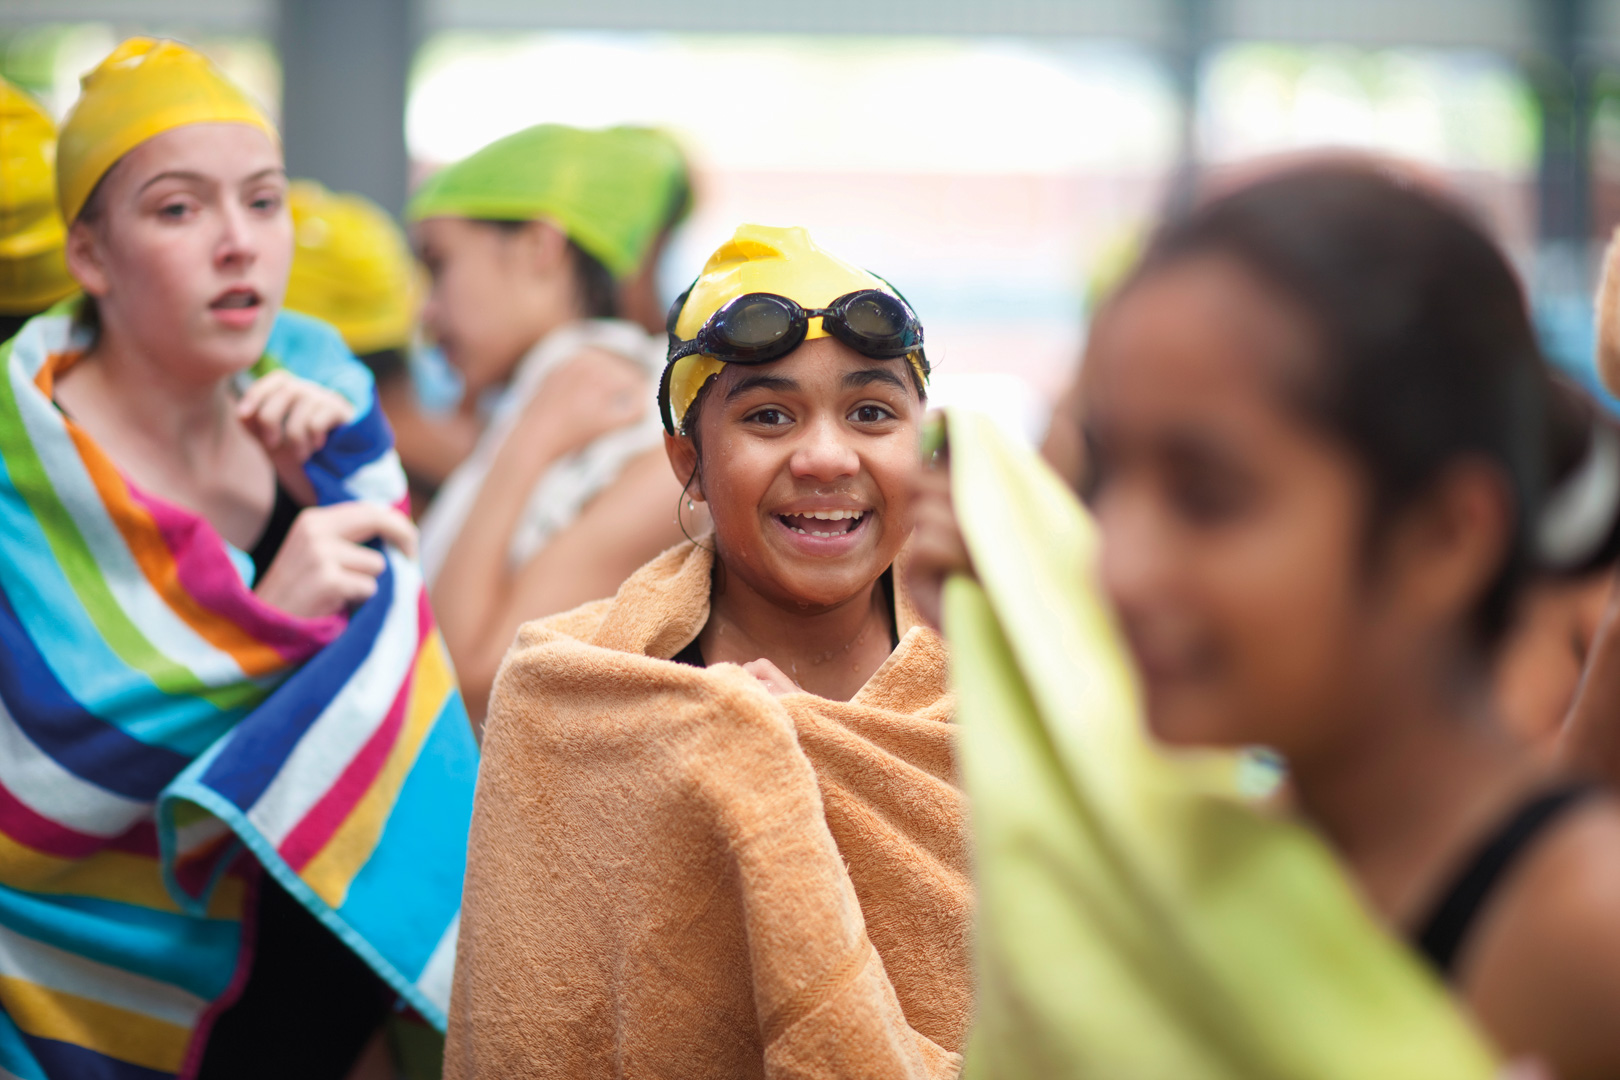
411, 217, 556, 393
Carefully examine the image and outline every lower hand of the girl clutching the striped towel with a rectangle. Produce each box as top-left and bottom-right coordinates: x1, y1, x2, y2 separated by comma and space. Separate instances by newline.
253, 502, 416, 619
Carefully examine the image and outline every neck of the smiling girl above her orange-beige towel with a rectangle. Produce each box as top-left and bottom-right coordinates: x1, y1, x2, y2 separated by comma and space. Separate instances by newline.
698, 563, 894, 701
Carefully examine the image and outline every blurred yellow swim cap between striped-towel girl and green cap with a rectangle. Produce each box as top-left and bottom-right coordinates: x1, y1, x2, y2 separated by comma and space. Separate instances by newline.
285, 180, 420, 356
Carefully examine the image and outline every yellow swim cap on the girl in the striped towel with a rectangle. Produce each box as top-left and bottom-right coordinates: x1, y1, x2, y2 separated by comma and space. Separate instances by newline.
57, 37, 280, 225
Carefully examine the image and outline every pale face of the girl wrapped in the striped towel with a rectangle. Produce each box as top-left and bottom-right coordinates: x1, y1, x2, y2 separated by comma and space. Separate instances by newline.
68, 123, 293, 381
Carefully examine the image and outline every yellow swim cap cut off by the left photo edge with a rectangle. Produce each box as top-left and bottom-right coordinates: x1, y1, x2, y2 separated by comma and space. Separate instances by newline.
0, 79, 78, 316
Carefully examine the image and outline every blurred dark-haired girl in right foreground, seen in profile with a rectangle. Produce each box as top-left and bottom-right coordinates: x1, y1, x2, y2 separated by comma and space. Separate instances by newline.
917, 167, 1620, 1080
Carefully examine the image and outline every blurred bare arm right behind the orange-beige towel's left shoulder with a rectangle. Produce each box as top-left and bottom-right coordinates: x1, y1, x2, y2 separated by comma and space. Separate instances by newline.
434, 447, 682, 716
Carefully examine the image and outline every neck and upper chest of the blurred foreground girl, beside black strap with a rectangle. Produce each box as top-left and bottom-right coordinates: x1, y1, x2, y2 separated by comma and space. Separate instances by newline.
1290, 680, 1541, 926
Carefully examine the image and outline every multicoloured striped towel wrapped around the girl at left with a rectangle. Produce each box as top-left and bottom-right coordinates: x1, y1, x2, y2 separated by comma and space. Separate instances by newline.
0, 306, 478, 1080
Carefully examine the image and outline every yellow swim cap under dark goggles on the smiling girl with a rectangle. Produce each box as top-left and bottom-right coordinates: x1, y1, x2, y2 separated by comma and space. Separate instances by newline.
664, 225, 928, 431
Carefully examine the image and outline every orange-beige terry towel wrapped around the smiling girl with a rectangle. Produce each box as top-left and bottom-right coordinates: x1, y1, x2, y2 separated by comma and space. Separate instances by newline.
446, 544, 972, 1080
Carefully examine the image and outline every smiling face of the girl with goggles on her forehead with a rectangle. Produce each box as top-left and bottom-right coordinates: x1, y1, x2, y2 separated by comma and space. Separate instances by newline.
669, 338, 923, 614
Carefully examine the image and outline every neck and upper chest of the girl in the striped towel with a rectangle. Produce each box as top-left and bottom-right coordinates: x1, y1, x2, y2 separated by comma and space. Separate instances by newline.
68, 329, 235, 463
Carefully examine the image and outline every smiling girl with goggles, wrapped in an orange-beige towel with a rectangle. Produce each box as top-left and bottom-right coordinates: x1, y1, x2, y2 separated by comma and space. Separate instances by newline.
446, 225, 972, 1080
